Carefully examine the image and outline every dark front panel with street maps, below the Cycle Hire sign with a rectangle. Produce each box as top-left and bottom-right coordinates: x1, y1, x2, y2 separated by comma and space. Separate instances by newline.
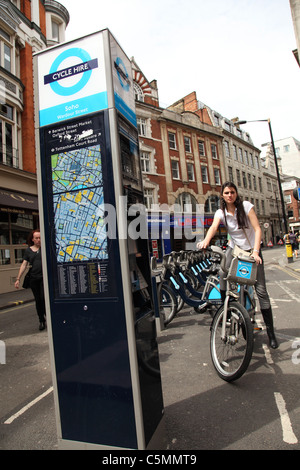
41, 111, 137, 448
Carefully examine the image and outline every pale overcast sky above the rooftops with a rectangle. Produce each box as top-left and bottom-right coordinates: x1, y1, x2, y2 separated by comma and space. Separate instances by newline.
59, 0, 300, 148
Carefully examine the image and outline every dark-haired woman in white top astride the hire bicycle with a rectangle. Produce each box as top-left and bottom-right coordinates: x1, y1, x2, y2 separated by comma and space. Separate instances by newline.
197, 181, 278, 349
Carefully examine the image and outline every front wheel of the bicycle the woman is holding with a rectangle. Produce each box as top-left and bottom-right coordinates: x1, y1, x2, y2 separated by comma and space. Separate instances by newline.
210, 302, 253, 382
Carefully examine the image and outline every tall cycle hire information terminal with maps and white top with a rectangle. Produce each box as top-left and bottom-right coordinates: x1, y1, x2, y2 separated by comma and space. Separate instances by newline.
34, 29, 164, 449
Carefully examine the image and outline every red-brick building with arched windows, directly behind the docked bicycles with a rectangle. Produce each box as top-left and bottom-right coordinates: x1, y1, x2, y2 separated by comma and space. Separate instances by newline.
132, 59, 225, 258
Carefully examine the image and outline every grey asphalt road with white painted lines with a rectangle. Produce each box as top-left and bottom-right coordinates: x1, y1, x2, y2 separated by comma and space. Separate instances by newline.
0, 248, 300, 451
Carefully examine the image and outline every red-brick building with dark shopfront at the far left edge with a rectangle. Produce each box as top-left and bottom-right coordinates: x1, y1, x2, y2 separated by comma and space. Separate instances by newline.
0, 0, 69, 293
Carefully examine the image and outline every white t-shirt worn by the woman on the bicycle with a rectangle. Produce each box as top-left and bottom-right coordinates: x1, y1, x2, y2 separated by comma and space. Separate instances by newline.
215, 201, 255, 250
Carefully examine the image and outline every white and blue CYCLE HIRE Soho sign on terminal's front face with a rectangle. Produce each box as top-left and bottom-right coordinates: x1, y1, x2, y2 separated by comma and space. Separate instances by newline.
38, 33, 108, 127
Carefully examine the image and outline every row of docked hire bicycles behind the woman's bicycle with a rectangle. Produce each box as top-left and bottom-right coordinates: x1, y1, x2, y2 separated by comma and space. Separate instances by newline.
151, 246, 256, 326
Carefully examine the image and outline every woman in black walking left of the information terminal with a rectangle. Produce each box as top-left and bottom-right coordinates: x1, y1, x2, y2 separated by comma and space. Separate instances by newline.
15, 229, 46, 330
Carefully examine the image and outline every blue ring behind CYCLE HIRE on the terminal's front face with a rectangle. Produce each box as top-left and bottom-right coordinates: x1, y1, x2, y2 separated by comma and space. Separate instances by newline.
50, 47, 92, 96
